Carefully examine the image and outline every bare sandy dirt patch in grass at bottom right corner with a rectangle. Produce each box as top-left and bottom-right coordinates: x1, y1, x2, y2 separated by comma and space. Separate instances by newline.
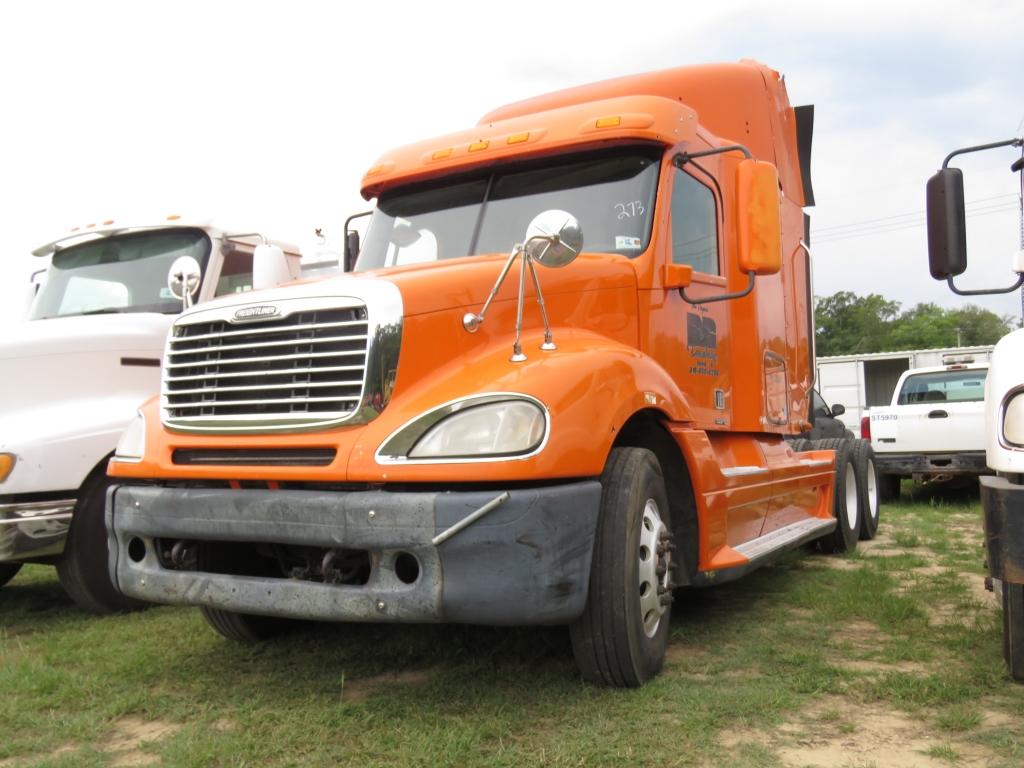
722, 696, 996, 768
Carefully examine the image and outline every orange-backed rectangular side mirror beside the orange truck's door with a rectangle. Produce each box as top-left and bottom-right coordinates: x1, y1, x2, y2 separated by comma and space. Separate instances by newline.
736, 160, 782, 274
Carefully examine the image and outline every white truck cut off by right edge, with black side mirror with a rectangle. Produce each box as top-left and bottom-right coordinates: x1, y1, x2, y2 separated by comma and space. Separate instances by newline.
927, 137, 1024, 681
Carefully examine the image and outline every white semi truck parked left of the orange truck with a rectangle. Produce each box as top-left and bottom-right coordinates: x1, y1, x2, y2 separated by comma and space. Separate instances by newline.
0, 216, 300, 612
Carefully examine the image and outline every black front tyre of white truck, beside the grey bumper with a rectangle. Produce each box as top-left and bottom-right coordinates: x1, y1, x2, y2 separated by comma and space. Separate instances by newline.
57, 474, 143, 615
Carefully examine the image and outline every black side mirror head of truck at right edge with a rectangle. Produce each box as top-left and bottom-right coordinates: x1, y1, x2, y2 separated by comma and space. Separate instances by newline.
927, 168, 967, 280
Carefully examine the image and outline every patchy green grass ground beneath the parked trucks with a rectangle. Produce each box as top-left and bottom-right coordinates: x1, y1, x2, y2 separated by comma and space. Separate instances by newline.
0, 492, 1024, 768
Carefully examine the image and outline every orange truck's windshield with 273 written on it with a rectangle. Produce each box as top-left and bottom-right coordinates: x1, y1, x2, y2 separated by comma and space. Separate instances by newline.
355, 147, 660, 271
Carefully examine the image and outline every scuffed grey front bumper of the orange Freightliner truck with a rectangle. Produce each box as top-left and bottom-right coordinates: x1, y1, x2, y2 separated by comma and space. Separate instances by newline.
106, 480, 601, 625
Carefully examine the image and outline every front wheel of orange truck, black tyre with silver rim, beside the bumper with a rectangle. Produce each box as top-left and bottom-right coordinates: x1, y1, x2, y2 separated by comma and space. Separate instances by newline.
569, 447, 674, 687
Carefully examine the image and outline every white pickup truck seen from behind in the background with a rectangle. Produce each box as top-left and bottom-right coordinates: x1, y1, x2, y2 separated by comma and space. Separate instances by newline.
861, 364, 988, 499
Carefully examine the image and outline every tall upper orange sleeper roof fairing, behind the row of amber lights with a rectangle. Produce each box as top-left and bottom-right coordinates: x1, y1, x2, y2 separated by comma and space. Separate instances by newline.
478, 59, 810, 206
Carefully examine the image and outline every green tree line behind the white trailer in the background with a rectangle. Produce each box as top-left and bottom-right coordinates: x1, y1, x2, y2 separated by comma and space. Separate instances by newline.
814, 291, 1014, 356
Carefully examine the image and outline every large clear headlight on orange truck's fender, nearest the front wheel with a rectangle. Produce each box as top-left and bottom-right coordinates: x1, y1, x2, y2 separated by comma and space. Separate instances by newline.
409, 400, 546, 459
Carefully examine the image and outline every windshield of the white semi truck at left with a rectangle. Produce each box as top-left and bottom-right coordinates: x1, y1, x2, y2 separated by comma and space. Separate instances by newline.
31, 229, 210, 319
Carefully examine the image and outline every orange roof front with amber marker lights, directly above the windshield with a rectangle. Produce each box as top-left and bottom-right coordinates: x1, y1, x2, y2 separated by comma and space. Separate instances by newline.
361, 94, 697, 200
